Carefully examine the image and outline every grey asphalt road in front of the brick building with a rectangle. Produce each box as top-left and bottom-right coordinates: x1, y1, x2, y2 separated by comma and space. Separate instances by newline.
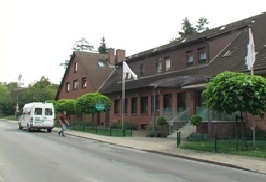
0, 121, 266, 182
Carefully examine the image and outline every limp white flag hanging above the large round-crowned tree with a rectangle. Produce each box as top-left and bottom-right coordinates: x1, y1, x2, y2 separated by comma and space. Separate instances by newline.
247, 28, 256, 70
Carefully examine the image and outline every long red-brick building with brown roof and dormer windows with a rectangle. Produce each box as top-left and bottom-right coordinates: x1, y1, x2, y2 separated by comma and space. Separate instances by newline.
57, 13, 266, 136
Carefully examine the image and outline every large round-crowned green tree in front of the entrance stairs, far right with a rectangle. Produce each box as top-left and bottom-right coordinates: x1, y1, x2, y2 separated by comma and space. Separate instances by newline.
203, 71, 266, 149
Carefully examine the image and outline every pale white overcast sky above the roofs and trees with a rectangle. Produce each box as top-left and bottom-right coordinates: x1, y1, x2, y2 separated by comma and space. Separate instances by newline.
0, 0, 266, 86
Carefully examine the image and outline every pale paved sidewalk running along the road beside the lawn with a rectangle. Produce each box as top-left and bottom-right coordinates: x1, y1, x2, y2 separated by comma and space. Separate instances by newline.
53, 128, 266, 175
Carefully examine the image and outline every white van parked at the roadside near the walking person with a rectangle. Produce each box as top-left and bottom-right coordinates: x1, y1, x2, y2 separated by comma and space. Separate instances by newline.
19, 102, 54, 132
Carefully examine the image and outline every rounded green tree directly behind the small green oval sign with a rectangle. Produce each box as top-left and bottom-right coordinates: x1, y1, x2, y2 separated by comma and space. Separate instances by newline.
76, 93, 112, 123
